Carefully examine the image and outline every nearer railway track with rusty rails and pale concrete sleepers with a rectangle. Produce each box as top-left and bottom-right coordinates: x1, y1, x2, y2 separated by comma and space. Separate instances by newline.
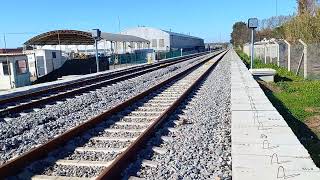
0, 51, 226, 179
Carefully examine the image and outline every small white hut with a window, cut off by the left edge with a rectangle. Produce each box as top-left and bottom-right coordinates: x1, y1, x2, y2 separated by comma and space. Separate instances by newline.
0, 54, 31, 90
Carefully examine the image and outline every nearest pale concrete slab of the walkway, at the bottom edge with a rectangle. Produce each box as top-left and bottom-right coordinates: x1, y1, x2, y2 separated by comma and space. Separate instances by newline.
232, 155, 320, 180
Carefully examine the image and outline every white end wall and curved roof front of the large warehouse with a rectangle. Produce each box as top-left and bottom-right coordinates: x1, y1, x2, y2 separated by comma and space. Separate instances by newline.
121, 27, 170, 51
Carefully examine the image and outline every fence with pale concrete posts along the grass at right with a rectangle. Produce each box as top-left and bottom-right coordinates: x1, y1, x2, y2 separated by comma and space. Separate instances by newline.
243, 39, 320, 79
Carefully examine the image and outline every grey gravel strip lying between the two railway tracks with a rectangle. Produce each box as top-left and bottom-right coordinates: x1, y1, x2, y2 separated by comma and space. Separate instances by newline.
0, 54, 215, 165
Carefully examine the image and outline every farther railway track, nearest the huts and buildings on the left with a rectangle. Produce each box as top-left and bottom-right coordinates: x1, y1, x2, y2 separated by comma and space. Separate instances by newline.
0, 52, 207, 120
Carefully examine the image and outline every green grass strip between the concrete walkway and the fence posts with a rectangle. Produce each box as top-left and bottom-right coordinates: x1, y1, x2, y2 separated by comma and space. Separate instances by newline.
237, 51, 320, 167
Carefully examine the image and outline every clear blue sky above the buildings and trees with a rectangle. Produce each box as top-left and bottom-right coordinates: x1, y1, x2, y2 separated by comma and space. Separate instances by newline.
0, 0, 296, 47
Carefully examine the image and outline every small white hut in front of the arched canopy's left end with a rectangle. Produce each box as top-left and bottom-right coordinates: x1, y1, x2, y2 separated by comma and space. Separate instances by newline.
25, 49, 67, 79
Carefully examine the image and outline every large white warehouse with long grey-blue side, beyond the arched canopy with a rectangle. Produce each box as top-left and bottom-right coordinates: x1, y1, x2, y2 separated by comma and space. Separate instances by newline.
121, 27, 204, 51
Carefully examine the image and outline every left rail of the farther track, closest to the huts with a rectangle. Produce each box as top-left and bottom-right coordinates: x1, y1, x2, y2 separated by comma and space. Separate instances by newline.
0, 52, 207, 105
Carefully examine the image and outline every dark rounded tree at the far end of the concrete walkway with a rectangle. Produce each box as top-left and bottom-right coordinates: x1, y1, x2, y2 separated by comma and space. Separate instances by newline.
230, 22, 250, 48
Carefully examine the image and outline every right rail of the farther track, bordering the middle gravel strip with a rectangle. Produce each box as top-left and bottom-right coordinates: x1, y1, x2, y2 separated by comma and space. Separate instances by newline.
0, 52, 214, 117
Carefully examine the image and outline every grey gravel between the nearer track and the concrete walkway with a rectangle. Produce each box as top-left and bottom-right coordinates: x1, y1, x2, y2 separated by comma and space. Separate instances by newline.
123, 53, 231, 180
